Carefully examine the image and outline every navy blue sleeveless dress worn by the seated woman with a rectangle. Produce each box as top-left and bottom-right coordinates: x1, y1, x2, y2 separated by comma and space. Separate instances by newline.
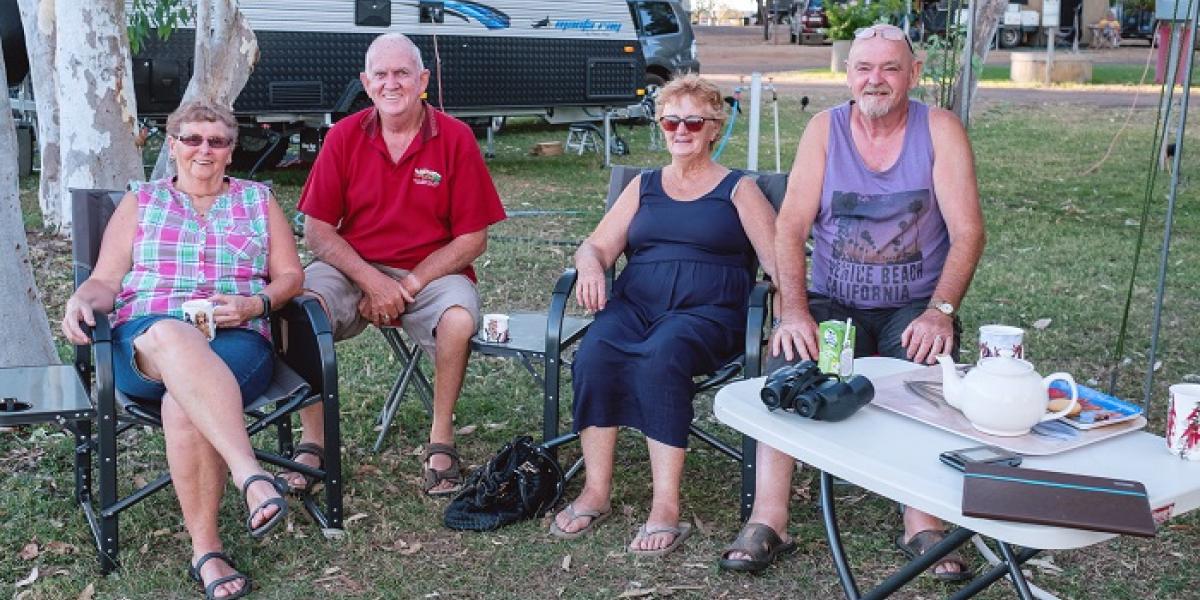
571, 170, 756, 448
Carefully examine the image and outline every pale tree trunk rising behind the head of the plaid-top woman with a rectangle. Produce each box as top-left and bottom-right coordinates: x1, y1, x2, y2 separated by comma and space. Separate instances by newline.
151, 0, 258, 179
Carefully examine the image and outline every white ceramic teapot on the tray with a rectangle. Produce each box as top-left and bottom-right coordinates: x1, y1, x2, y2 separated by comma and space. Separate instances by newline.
937, 355, 1079, 437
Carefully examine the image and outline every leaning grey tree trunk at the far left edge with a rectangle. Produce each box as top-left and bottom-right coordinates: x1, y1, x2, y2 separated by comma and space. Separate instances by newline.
0, 41, 59, 367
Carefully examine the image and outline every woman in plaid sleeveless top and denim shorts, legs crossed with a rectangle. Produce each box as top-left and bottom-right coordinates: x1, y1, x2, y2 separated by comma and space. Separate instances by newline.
62, 102, 302, 599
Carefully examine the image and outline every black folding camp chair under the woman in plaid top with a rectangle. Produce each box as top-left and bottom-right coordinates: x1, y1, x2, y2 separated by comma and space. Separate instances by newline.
71, 190, 343, 574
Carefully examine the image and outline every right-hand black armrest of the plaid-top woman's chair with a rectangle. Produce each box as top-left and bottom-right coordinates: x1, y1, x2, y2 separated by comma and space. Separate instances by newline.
271, 296, 337, 394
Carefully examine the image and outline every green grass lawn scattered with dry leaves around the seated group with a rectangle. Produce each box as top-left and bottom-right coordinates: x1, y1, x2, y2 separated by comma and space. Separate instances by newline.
0, 95, 1200, 600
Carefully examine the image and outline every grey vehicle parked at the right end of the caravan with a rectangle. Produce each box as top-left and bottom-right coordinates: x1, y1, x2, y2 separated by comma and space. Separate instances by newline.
628, 0, 700, 88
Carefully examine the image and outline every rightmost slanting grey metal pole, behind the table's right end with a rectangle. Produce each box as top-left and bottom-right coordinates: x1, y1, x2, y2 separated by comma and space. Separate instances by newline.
1142, 5, 1200, 412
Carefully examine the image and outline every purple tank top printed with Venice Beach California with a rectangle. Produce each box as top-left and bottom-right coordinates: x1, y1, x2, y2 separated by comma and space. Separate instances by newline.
812, 100, 950, 308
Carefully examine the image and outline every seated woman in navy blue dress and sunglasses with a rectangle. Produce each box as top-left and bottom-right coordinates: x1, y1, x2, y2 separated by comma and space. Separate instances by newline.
551, 76, 775, 556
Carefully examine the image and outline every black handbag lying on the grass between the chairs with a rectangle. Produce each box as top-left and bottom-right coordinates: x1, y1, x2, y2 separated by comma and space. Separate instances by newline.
443, 436, 563, 532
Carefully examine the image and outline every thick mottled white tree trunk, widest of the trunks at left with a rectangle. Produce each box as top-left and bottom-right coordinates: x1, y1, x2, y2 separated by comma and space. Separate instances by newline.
53, 0, 145, 230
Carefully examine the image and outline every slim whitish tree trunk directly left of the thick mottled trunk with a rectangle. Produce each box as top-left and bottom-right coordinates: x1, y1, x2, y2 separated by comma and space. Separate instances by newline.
17, 0, 61, 229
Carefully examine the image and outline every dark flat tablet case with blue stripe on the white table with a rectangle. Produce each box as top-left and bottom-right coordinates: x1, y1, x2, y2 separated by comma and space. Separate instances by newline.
962, 463, 1154, 538
